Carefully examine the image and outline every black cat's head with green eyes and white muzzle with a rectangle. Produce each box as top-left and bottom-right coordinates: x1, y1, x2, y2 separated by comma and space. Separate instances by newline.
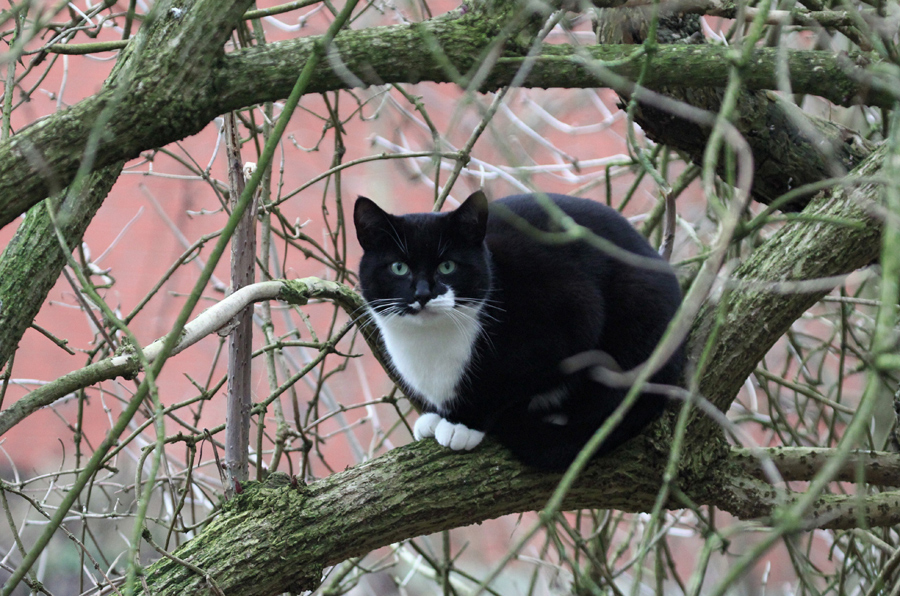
353, 191, 491, 319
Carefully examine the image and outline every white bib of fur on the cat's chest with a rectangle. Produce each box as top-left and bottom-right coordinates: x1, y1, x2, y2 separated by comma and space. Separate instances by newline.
372, 290, 481, 410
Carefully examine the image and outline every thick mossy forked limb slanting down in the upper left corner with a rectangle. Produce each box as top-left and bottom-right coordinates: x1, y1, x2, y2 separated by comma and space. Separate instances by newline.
0, 0, 260, 374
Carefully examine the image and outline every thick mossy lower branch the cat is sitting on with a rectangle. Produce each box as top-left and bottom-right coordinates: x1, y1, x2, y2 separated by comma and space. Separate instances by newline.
132, 437, 900, 596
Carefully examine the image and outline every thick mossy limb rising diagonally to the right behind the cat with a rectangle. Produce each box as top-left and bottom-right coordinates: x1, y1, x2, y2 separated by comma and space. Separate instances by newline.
691, 147, 886, 424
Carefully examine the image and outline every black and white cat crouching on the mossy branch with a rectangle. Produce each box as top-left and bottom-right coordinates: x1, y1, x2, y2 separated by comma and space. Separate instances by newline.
354, 191, 684, 470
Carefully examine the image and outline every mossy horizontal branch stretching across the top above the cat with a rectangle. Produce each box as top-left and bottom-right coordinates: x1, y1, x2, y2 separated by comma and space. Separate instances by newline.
220, 43, 895, 109
